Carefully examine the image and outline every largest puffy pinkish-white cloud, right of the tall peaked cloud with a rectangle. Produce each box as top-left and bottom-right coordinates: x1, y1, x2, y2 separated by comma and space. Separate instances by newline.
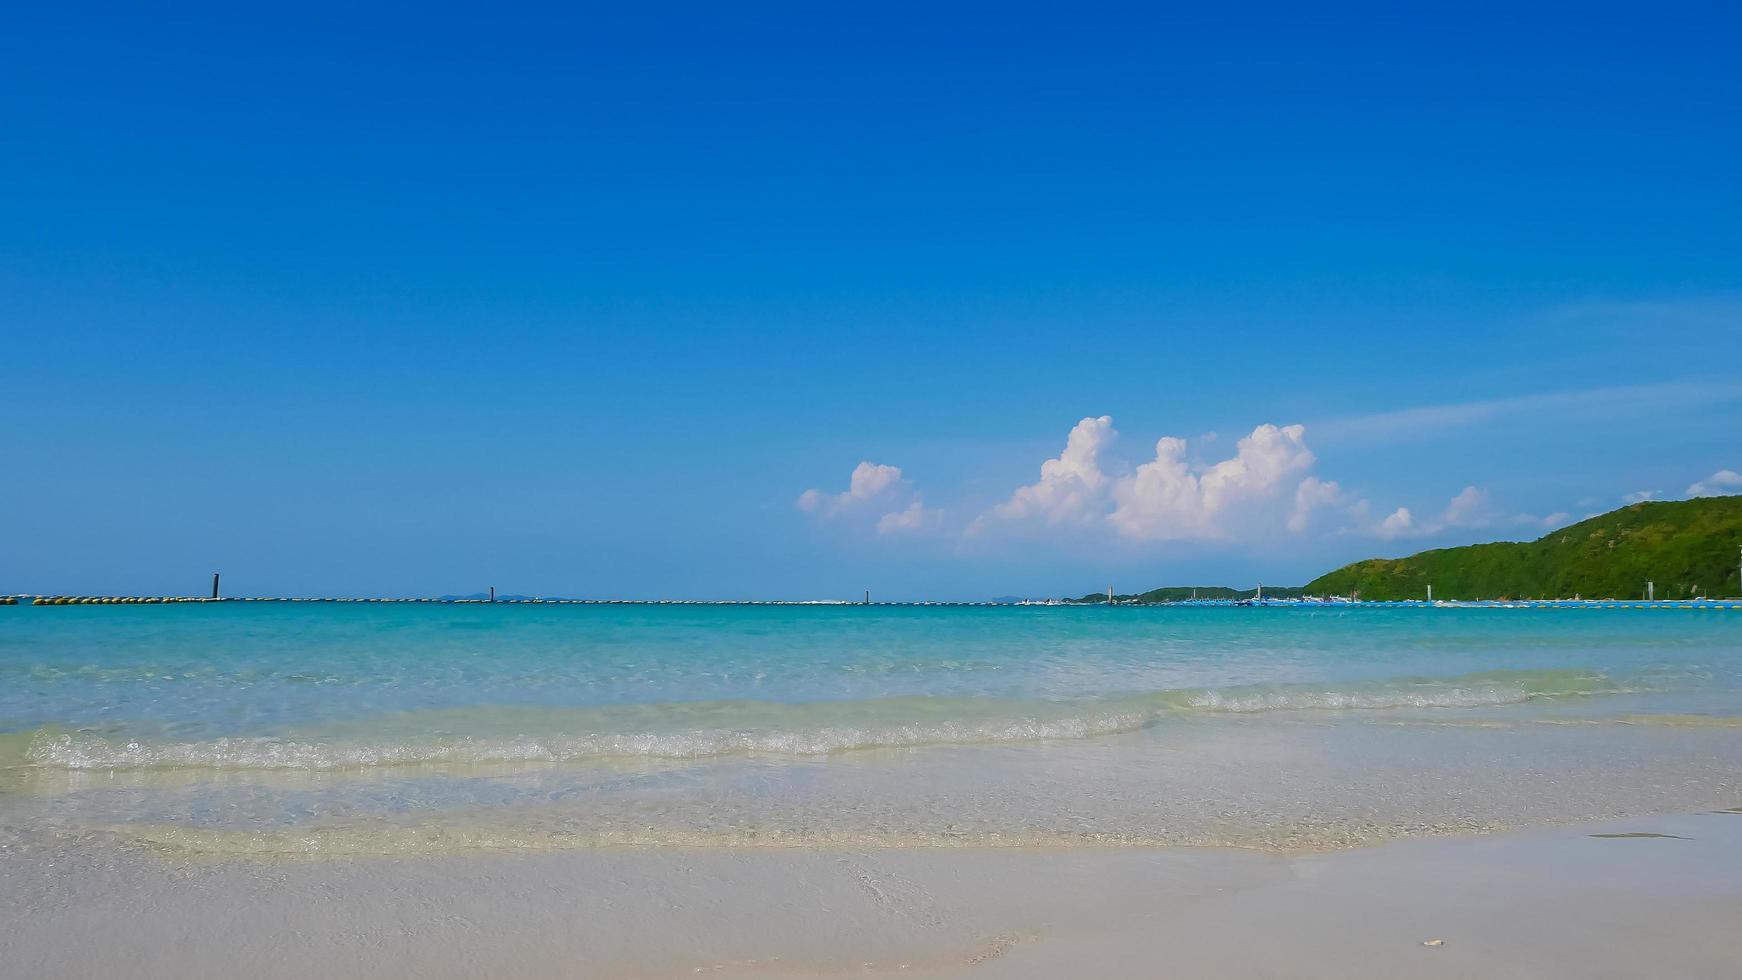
1108, 425, 1313, 541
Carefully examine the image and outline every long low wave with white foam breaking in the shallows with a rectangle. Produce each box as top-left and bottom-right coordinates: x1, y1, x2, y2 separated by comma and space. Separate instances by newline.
0, 670, 1639, 771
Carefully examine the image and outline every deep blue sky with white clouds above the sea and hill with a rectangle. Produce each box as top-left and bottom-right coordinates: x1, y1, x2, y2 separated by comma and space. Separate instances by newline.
0, 3, 1742, 597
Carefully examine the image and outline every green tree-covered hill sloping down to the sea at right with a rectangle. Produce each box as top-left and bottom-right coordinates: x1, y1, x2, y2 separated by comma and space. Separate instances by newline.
1307, 496, 1742, 599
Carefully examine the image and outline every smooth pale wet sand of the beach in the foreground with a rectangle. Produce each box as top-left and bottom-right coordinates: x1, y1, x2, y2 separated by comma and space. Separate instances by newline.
0, 811, 1742, 980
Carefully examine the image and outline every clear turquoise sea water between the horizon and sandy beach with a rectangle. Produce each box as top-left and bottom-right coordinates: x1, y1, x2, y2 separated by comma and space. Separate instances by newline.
0, 602, 1742, 853
